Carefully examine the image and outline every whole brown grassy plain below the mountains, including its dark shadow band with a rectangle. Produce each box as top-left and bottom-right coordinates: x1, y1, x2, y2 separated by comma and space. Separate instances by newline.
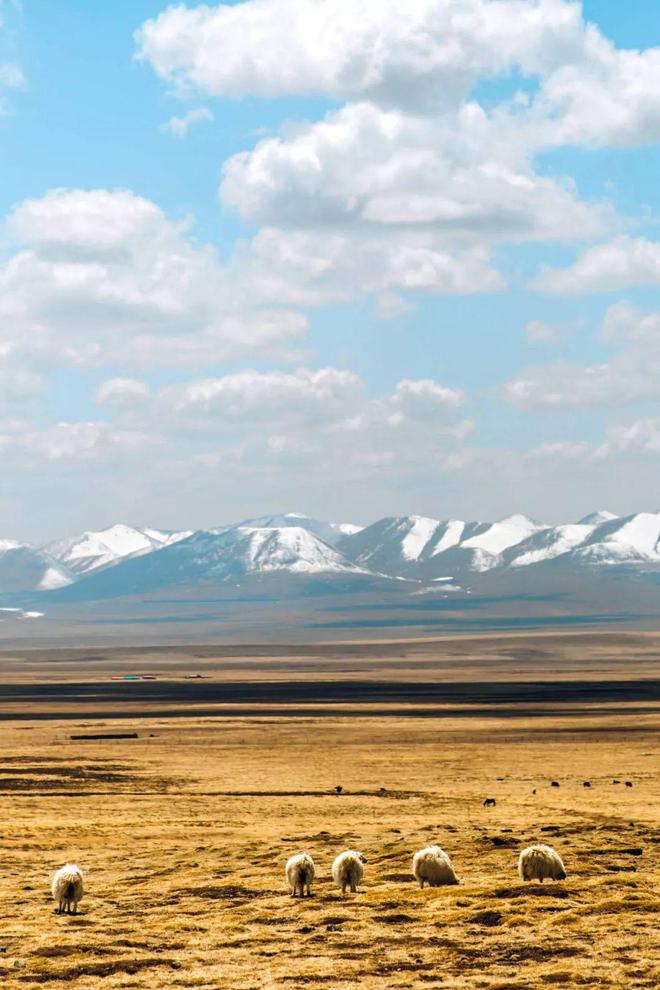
0, 633, 660, 990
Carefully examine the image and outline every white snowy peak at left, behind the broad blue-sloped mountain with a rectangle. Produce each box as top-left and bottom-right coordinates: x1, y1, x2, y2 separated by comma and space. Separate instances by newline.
43, 523, 192, 575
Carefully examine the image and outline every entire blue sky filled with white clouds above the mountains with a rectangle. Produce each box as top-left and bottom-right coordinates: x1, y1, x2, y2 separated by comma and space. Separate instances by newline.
0, 0, 660, 543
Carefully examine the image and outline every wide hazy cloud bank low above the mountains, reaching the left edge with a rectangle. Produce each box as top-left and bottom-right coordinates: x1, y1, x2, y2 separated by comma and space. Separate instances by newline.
0, 367, 472, 524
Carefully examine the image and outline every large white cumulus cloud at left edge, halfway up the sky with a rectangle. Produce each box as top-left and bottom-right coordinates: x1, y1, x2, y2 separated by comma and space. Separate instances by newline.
0, 189, 307, 367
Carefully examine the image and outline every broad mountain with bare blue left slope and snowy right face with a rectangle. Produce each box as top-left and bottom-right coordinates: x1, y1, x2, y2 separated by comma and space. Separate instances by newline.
50, 526, 370, 598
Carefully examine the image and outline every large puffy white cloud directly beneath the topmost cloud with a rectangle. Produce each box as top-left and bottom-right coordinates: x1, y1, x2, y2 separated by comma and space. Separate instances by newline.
221, 103, 612, 243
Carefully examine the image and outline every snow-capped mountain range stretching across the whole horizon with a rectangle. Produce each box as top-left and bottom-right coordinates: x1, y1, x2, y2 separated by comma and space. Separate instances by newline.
0, 511, 660, 599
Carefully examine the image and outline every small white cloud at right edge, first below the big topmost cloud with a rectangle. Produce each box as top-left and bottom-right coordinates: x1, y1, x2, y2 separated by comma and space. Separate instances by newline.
534, 236, 660, 295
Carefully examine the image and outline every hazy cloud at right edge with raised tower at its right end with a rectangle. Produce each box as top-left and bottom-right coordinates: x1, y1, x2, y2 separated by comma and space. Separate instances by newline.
505, 302, 660, 410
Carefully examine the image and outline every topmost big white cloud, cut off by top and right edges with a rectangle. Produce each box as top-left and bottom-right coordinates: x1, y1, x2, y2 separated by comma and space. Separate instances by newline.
136, 0, 660, 146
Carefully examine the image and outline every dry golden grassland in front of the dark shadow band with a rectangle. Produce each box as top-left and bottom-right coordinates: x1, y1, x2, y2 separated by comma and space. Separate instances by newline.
0, 632, 660, 990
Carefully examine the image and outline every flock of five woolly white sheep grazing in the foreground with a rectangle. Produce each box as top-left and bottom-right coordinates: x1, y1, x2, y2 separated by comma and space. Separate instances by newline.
51, 845, 566, 914
